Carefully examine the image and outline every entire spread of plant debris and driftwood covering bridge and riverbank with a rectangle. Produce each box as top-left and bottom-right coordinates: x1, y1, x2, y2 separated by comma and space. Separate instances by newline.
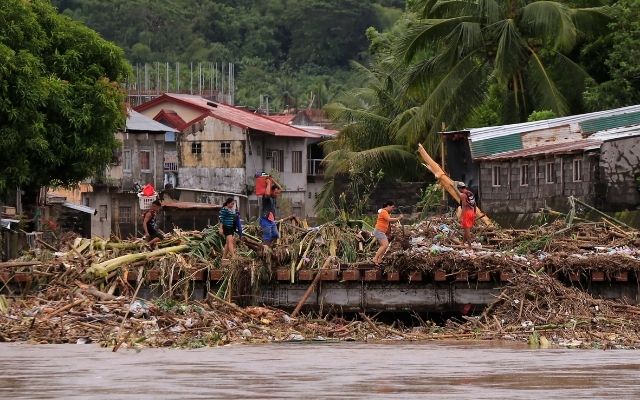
0, 212, 640, 351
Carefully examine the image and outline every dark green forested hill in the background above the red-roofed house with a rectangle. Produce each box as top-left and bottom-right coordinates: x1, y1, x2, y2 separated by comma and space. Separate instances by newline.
52, 0, 405, 107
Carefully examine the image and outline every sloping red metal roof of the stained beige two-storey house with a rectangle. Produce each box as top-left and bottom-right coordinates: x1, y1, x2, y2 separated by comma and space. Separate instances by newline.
136, 93, 318, 138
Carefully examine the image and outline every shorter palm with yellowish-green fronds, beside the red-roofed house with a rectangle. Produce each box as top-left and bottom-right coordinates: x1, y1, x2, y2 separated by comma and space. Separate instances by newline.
316, 54, 435, 214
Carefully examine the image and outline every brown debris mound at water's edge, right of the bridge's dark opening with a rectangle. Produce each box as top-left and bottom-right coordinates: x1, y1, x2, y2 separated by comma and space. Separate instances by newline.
452, 273, 640, 348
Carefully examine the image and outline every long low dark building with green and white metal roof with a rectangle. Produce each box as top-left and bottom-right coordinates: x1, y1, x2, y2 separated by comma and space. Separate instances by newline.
443, 105, 640, 214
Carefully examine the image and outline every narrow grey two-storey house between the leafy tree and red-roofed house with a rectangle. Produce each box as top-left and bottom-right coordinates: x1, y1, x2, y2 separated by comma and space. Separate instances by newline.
82, 110, 177, 238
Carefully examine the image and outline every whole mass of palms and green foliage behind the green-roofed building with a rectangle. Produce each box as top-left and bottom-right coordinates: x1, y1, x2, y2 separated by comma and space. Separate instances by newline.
317, 0, 640, 212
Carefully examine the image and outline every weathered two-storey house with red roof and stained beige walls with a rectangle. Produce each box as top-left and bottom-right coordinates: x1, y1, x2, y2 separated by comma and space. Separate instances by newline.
136, 93, 320, 217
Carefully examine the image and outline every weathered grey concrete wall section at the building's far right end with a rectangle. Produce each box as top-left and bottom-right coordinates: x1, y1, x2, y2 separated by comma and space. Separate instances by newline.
600, 137, 640, 210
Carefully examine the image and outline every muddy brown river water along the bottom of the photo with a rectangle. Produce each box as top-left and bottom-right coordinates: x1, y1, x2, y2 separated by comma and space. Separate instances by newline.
0, 342, 640, 399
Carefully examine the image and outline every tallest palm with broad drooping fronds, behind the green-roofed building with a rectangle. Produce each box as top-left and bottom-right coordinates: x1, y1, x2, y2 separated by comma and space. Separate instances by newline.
399, 0, 608, 136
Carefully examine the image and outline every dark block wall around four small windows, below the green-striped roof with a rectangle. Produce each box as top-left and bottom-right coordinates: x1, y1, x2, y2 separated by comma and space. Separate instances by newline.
477, 154, 598, 214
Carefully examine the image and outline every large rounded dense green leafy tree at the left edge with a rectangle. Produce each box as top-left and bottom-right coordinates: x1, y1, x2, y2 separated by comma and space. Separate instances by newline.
0, 0, 128, 192
